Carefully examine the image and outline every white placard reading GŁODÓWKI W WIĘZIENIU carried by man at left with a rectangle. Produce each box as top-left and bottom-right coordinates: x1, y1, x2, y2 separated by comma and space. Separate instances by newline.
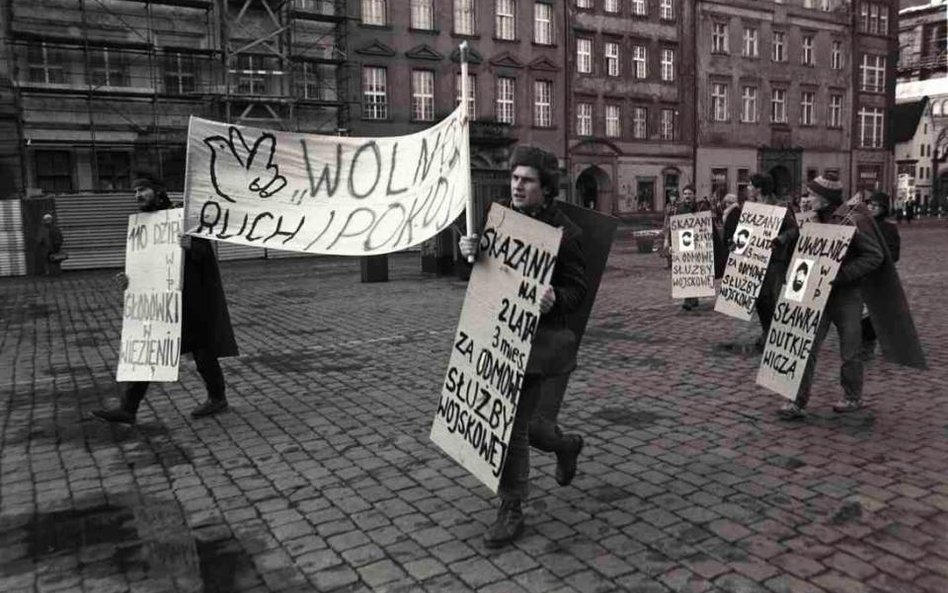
115, 208, 184, 381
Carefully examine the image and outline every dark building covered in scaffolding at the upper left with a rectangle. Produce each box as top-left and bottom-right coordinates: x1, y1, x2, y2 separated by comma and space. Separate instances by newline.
2, 0, 346, 197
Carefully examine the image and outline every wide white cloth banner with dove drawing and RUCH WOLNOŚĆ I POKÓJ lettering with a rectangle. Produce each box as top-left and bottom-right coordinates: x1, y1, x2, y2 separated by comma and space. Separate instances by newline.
184, 107, 471, 255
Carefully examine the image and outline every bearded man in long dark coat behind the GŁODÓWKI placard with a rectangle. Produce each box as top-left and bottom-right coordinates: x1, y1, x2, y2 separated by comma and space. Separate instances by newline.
92, 174, 237, 424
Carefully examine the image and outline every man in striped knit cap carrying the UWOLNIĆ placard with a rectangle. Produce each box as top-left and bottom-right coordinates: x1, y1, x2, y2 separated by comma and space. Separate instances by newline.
778, 173, 885, 420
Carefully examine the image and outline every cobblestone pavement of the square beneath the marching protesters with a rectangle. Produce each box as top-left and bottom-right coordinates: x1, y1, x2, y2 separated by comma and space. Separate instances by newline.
0, 225, 948, 593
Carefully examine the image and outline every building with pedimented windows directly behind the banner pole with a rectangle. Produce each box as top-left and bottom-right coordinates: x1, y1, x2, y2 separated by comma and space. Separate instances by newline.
348, 0, 567, 202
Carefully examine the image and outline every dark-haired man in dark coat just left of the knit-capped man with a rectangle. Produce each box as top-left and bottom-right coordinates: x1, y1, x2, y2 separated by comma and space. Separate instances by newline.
747, 173, 800, 350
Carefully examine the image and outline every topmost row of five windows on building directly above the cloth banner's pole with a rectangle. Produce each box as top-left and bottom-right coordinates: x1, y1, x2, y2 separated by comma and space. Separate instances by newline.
362, 0, 556, 45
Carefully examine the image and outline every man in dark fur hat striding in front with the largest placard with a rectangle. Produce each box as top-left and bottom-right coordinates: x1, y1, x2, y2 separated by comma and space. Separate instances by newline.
459, 146, 586, 548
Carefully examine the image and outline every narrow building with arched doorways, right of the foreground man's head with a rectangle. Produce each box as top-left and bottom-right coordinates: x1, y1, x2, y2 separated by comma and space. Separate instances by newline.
567, 0, 694, 216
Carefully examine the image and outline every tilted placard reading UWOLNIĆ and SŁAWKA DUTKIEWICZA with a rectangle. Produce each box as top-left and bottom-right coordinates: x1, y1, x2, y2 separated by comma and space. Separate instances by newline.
757, 222, 856, 400
